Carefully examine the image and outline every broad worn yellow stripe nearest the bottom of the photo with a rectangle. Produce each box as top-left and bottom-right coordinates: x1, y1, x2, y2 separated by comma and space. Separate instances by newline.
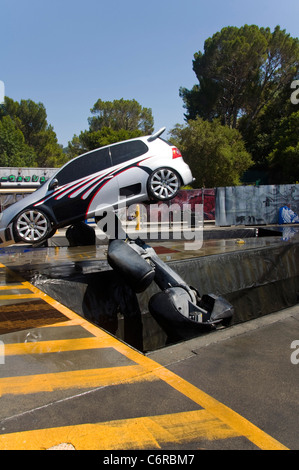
0, 410, 239, 450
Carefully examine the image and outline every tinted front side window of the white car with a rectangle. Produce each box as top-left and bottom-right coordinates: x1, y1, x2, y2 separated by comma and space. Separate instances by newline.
55, 148, 111, 186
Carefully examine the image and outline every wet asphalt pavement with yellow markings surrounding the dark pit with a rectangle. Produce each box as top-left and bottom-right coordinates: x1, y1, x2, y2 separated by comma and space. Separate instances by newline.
0, 228, 299, 453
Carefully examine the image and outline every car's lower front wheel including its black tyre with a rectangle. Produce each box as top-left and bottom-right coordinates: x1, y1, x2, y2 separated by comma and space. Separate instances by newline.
13, 208, 53, 244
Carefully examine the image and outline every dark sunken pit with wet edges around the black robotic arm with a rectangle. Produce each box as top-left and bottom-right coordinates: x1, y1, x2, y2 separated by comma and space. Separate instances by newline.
7, 229, 299, 353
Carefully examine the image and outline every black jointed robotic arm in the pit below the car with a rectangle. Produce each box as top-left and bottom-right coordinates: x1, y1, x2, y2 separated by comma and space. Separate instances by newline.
107, 235, 233, 340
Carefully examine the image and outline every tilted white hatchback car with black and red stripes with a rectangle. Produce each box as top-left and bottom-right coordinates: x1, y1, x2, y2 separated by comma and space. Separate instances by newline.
0, 127, 193, 246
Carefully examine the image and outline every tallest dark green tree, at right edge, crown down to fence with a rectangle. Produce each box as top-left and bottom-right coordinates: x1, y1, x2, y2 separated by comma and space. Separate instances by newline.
180, 25, 299, 183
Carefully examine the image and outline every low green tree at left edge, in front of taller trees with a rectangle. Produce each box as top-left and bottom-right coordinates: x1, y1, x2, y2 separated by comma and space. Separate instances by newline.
0, 116, 37, 167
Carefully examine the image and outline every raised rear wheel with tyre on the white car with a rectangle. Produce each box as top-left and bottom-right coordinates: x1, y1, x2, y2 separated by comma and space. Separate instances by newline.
147, 167, 182, 201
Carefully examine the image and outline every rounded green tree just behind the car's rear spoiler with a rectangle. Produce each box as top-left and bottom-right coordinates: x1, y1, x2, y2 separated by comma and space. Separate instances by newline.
171, 118, 253, 188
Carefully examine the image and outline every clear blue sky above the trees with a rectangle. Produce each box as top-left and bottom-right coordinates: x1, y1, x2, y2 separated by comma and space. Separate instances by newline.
0, 0, 299, 145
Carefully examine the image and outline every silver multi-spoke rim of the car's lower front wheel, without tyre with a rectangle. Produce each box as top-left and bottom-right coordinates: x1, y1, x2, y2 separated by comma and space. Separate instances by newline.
16, 210, 48, 242
